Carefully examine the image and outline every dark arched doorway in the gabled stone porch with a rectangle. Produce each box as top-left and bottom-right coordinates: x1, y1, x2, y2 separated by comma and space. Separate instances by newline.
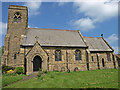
33, 56, 42, 71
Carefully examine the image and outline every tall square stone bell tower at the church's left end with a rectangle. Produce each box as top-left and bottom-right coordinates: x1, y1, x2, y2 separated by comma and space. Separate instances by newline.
2, 5, 28, 66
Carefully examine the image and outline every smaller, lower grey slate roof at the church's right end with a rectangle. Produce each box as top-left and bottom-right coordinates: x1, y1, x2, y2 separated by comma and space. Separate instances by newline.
84, 37, 112, 51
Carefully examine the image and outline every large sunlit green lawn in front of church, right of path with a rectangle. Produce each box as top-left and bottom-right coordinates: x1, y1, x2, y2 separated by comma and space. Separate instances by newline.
3, 69, 118, 88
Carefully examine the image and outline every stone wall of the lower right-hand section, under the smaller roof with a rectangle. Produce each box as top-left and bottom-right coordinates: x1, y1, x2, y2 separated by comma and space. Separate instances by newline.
89, 52, 118, 70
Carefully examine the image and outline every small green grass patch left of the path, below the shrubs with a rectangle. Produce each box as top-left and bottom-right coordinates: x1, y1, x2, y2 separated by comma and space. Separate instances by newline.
2, 74, 25, 86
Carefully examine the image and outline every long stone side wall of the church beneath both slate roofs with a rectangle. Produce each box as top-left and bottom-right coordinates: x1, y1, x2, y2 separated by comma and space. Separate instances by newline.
11, 44, 117, 74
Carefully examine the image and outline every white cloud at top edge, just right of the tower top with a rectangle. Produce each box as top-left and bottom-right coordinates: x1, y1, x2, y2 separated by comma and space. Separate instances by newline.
24, 2, 41, 16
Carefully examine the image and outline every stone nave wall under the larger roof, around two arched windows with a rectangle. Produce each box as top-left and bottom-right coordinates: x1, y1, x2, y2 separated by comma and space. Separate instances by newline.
23, 47, 87, 71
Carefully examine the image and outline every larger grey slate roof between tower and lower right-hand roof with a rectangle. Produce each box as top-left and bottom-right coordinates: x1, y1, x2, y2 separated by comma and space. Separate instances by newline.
22, 28, 87, 47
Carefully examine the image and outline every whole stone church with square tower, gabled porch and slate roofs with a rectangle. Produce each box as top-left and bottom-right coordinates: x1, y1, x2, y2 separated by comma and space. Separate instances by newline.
2, 5, 118, 75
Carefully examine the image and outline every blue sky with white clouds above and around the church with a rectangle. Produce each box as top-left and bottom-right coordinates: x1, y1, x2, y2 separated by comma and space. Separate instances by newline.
0, 0, 118, 53
